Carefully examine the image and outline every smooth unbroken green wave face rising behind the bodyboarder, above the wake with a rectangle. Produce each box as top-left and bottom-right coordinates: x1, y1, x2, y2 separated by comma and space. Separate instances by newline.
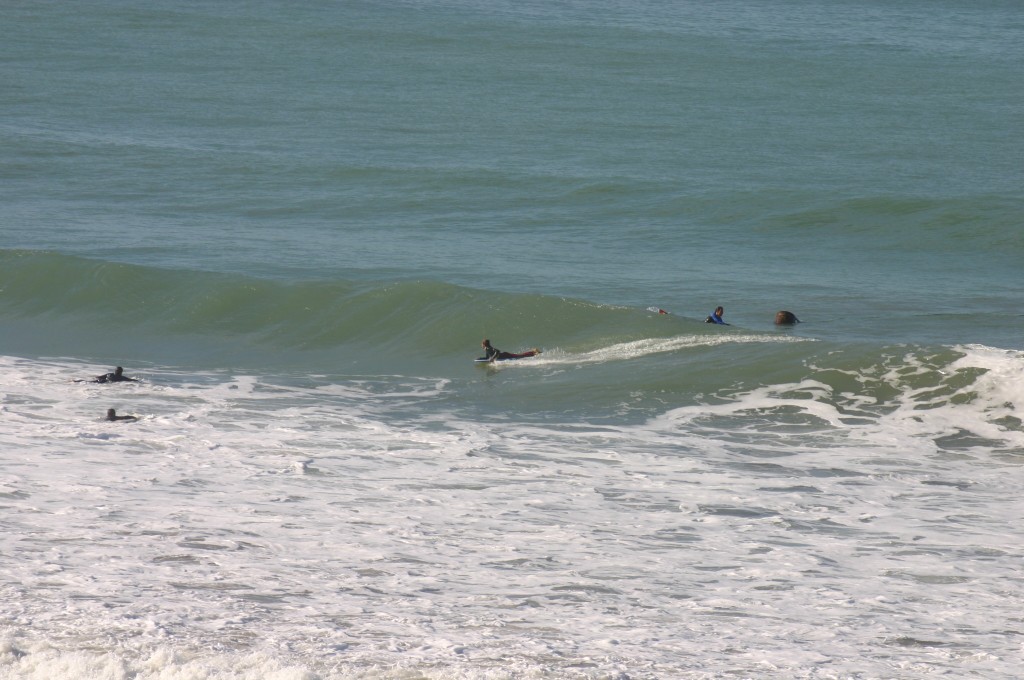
0, 251, 699, 370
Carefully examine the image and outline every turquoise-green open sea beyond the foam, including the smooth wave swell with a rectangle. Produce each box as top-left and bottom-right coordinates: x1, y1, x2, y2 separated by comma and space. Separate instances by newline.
0, 0, 1024, 370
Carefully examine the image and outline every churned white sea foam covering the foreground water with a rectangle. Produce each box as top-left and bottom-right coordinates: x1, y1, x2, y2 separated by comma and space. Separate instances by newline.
0, 348, 1024, 680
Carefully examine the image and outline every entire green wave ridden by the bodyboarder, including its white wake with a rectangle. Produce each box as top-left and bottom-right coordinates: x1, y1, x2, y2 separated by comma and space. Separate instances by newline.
0, 246, 1024, 411
